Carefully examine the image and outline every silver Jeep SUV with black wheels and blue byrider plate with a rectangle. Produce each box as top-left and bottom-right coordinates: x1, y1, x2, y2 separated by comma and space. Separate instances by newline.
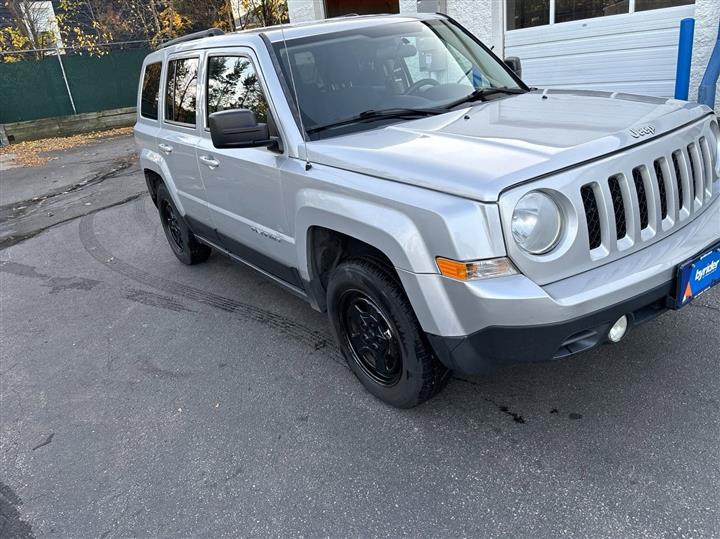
135, 15, 720, 407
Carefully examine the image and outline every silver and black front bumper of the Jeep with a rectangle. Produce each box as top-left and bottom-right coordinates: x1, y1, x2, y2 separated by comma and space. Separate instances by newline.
398, 194, 720, 373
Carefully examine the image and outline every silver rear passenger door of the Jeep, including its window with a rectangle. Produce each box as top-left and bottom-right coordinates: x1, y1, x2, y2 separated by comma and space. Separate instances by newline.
157, 51, 213, 239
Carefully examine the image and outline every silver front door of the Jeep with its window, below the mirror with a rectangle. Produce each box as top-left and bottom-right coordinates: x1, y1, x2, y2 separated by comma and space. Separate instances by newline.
197, 47, 301, 286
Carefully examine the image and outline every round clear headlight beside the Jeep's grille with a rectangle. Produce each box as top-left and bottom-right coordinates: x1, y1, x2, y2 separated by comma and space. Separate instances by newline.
511, 191, 562, 255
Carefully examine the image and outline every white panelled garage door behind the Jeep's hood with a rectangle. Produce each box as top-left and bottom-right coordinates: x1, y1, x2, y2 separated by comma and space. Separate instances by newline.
505, 0, 695, 97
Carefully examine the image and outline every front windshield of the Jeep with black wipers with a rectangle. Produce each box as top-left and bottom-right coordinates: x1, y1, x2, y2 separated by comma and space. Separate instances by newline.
274, 20, 523, 138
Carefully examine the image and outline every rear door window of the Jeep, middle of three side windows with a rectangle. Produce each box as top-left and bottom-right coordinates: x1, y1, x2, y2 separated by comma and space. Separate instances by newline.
165, 58, 198, 125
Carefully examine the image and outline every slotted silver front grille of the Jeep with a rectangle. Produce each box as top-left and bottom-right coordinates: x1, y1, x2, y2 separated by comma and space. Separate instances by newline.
580, 137, 713, 253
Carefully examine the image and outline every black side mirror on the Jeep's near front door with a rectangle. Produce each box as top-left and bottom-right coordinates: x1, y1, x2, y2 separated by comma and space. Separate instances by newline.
208, 109, 273, 148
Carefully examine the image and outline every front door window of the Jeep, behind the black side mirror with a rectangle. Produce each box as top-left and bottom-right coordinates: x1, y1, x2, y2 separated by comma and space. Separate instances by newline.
207, 56, 268, 123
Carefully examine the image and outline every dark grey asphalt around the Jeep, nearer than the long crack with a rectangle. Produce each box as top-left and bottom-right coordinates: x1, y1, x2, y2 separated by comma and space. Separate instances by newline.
0, 140, 720, 538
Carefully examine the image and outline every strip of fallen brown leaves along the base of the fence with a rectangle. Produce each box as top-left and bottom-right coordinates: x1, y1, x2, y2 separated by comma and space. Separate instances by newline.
0, 127, 132, 168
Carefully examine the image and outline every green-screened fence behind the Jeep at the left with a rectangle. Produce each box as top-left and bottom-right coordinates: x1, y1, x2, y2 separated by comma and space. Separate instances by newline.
0, 41, 150, 123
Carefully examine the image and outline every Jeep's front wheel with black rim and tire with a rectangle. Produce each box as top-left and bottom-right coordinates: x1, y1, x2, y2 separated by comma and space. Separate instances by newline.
327, 259, 450, 408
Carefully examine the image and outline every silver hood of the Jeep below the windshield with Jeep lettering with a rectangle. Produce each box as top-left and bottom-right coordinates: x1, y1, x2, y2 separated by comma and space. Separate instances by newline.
307, 90, 709, 202
